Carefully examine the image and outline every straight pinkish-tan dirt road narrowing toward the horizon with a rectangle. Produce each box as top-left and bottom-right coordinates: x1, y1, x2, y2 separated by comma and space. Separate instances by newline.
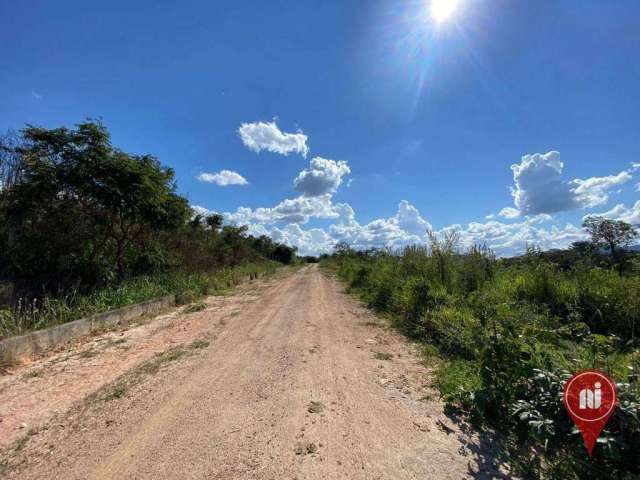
0, 266, 510, 480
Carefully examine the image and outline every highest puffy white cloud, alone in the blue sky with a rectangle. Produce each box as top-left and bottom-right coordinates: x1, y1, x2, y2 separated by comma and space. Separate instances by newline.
238, 121, 309, 157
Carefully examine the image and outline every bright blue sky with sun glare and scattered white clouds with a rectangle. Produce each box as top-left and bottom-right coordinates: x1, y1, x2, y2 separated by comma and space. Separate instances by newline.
0, 0, 640, 255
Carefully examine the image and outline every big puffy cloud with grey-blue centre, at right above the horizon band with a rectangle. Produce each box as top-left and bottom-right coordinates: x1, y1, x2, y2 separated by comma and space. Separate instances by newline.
503, 151, 632, 218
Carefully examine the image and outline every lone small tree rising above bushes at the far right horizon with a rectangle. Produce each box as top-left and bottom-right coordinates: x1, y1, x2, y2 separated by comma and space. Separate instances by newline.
582, 216, 638, 274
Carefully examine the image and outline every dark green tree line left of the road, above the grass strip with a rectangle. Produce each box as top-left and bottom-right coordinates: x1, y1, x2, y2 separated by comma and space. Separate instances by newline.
0, 120, 296, 295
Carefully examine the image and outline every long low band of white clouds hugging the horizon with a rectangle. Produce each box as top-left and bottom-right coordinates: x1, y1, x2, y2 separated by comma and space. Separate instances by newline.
200, 194, 592, 256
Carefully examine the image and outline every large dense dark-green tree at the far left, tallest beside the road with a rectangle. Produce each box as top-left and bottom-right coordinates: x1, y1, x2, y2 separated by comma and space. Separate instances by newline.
0, 121, 190, 286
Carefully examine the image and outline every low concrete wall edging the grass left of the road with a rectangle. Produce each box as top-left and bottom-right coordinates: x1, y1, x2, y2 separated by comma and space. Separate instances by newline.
0, 295, 176, 363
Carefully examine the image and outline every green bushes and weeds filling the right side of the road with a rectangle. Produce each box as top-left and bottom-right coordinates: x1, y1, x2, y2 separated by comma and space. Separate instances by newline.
322, 223, 640, 479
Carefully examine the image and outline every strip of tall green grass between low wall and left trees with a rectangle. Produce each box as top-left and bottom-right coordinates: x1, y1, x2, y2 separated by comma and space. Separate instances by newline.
0, 261, 281, 339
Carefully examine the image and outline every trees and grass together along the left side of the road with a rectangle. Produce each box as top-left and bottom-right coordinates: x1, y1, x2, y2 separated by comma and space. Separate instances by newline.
0, 120, 297, 339
